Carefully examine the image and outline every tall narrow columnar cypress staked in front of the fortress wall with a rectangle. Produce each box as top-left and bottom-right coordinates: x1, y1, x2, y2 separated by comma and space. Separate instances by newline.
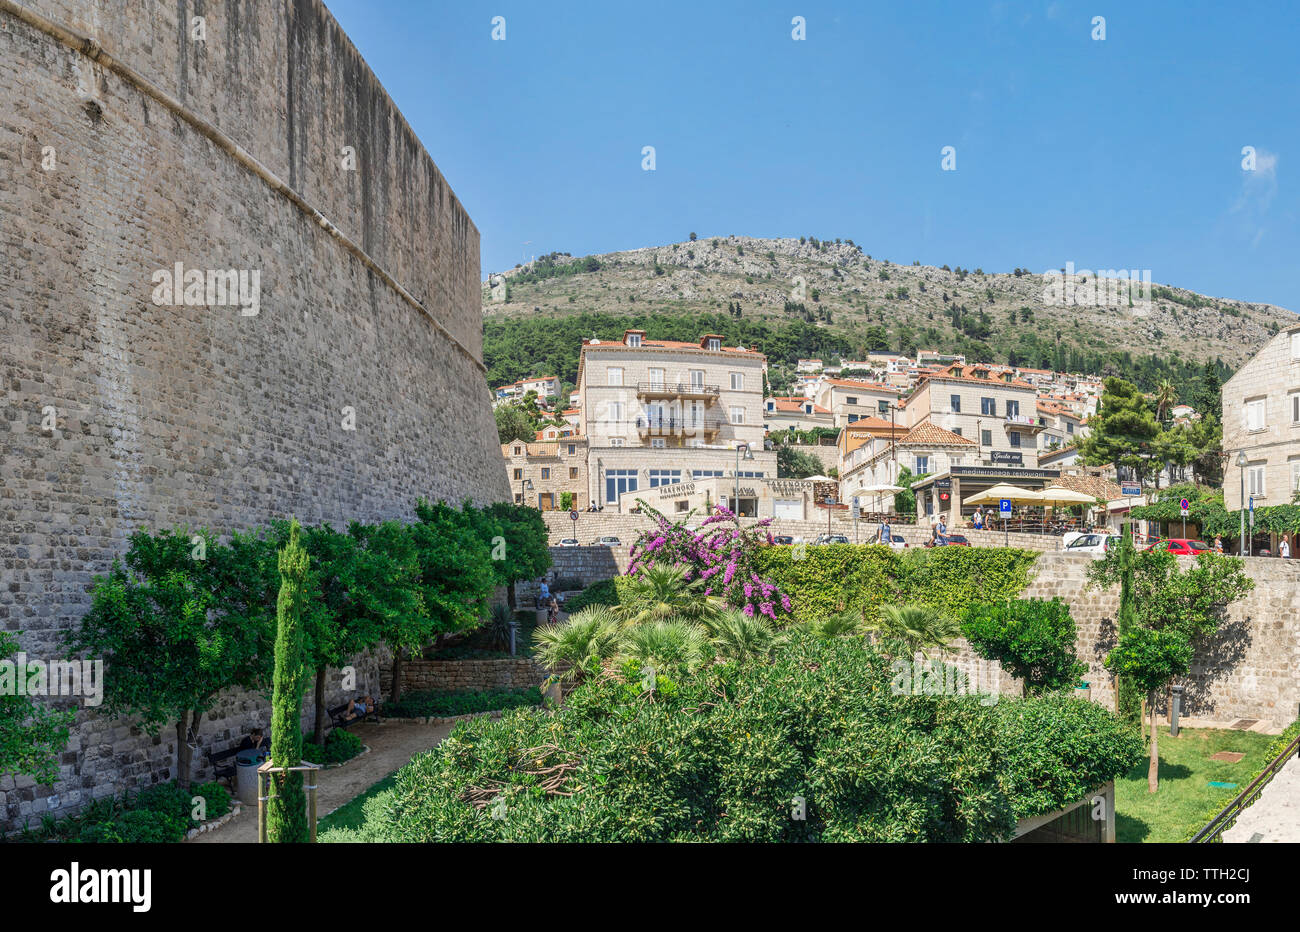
267, 520, 309, 844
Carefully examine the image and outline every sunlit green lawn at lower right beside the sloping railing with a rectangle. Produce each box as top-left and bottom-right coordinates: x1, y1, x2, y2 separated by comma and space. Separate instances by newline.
1115, 725, 1277, 842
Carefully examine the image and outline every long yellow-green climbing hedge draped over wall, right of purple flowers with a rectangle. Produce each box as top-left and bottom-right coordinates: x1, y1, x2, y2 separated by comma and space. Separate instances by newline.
755, 543, 1037, 621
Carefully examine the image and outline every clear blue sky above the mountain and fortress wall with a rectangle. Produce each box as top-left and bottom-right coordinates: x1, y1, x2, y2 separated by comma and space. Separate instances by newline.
325, 0, 1300, 311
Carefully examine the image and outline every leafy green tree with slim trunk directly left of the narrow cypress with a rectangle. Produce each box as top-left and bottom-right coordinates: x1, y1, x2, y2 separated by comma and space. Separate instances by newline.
65, 529, 268, 788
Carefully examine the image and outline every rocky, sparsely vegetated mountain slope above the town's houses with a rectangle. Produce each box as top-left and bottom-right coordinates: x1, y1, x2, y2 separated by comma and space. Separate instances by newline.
482, 237, 1295, 389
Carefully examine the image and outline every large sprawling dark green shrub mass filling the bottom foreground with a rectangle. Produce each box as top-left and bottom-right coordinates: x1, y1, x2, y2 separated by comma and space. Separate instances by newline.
335, 633, 1141, 842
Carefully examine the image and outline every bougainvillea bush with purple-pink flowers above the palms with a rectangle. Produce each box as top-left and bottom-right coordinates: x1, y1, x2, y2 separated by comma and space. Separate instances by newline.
628, 499, 792, 621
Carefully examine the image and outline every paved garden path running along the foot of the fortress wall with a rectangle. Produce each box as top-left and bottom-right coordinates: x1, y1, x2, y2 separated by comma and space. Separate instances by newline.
186, 721, 455, 845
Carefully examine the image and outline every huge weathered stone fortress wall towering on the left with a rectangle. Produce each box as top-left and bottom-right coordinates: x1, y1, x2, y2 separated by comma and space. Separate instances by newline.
0, 0, 510, 829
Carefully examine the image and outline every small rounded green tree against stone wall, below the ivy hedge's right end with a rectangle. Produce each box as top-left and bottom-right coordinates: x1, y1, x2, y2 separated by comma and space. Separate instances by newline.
962, 599, 1088, 695
